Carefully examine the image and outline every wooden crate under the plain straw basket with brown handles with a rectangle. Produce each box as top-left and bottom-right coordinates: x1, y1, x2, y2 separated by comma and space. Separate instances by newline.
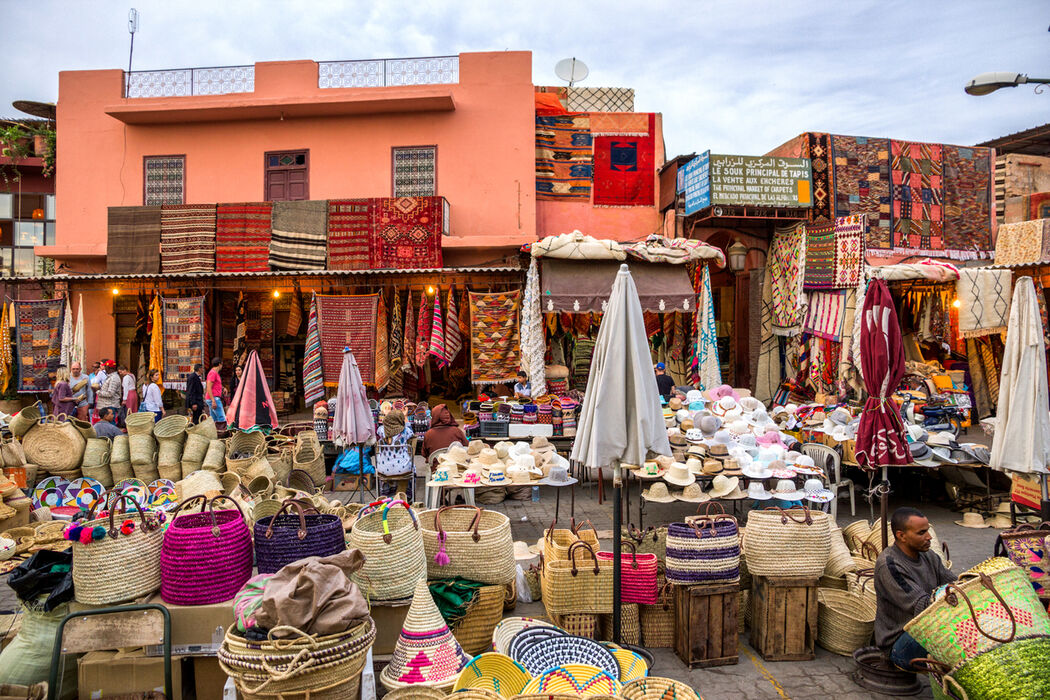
751, 576, 818, 661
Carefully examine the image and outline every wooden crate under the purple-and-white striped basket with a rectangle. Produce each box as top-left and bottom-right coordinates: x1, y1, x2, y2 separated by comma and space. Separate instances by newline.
674, 584, 740, 667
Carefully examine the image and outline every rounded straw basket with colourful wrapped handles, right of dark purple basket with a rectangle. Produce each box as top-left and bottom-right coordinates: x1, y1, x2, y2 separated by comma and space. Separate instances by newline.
350, 501, 426, 600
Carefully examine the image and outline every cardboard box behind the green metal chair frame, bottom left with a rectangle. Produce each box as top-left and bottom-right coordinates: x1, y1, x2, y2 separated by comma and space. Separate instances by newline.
77, 650, 183, 700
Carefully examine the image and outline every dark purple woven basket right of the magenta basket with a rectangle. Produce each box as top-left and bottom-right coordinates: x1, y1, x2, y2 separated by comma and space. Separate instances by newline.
255, 501, 347, 574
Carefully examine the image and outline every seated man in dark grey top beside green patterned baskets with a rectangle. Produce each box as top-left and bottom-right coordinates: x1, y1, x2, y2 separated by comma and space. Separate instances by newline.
875, 508, 956, 671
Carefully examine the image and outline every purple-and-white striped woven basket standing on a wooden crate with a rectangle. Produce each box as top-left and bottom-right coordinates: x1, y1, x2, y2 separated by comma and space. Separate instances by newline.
665, 514, 740, 586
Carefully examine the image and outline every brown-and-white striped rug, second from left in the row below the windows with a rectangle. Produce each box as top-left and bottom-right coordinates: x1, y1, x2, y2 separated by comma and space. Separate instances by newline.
161, 205, 215, 274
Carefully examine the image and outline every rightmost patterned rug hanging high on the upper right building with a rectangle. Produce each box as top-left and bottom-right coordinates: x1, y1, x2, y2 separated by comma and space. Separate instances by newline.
943, 146, 991, 259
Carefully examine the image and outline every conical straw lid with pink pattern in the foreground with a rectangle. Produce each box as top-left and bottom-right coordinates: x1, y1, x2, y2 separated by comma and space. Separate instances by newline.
379, 580, 470, 690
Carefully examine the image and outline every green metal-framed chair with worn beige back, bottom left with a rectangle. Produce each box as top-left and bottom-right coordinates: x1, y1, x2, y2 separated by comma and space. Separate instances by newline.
47, 603, 173, 700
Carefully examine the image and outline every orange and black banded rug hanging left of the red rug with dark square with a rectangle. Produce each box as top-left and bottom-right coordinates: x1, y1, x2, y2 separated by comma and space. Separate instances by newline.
536, 114, 594, 201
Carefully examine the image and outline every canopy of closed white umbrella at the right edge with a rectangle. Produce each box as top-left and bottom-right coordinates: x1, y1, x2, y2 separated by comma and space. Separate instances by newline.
989, 277, 1050, 474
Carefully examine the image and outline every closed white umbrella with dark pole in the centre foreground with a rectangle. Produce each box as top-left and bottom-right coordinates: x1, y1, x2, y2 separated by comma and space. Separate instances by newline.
571, 264, 671, 641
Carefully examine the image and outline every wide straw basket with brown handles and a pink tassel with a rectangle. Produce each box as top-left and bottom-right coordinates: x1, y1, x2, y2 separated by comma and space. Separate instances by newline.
419, 506, 514, 583
